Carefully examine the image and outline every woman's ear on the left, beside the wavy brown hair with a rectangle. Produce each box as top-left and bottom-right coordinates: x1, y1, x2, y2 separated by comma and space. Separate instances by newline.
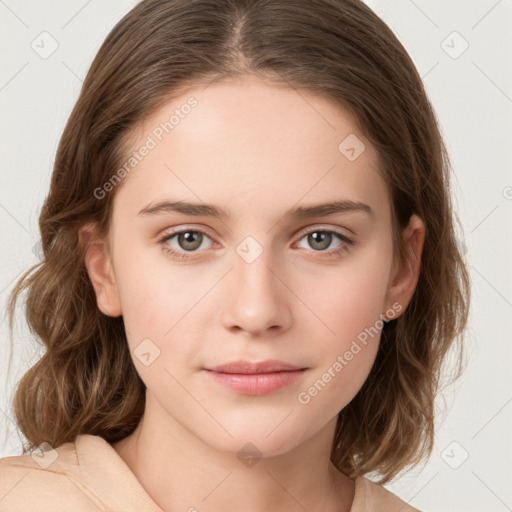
78, 224, 122, 317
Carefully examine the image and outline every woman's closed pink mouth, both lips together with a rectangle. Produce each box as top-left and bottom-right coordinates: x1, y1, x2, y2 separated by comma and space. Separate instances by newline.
204, 360, 308, 396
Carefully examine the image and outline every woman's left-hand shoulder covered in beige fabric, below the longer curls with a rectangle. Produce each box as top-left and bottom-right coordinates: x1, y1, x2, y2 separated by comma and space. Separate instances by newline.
0, 442, 103, 512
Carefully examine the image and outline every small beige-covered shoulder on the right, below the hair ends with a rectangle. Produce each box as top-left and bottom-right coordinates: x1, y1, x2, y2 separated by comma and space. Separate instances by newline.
350, 476, 421, 512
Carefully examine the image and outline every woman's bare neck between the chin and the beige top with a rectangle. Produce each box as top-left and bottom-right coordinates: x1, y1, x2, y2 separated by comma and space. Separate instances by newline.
112, 394, 354, 512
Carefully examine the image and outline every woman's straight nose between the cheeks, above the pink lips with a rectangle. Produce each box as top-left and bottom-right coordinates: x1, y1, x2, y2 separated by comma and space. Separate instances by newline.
222, 245, 293, 337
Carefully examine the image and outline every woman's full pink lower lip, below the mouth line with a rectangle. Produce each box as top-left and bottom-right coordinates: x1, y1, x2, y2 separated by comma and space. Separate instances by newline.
206, 369, 306, 396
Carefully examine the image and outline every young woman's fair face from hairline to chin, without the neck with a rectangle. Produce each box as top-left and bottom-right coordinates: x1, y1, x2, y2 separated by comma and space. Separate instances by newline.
83, 77, 415, 456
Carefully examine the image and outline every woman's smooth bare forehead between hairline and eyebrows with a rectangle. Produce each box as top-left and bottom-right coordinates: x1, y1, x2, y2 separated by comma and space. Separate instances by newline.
116, 77, 389, 224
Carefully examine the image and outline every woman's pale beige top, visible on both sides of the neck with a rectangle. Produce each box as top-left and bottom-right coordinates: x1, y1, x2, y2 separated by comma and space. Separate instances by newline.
0, 434, 420, 512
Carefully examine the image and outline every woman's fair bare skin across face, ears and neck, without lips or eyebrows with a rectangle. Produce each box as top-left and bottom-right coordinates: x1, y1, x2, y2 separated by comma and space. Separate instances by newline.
80, 76, 425, 512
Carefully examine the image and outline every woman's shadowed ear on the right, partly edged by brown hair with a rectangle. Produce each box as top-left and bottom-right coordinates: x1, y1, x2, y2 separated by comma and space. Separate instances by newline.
386, 214, 425, 320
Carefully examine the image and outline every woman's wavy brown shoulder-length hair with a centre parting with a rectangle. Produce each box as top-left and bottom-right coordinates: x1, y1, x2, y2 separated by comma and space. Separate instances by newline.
4, 0, 470, 484
